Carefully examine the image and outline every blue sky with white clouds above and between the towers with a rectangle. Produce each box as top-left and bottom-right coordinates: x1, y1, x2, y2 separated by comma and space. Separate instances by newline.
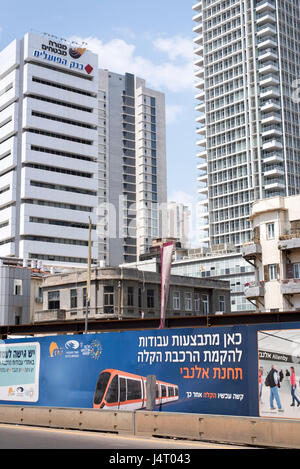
0, 0, 197, 207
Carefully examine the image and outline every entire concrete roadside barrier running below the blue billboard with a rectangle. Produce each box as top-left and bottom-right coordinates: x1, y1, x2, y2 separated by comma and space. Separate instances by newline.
0, 405, 300, 449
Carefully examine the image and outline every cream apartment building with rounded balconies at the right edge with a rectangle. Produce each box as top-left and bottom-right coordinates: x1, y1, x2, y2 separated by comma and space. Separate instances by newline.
242, 195, 300, 312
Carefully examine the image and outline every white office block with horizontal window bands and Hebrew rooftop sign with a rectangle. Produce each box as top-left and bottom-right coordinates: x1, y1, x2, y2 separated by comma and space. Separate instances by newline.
0, 34, 98, 266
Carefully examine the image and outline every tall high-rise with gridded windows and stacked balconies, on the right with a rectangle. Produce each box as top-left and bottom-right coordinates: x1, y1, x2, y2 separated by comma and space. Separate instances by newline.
193, 0, 300, 246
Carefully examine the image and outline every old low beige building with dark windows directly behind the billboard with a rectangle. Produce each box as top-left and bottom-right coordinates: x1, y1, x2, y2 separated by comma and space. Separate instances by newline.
35, 266, 230, 322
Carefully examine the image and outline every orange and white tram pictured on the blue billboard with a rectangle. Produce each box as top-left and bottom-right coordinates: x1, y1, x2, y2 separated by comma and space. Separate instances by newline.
93, 369, 179, 410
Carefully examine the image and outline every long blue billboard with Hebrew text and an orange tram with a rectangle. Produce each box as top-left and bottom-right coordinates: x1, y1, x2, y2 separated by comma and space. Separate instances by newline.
0, 323, 300, 418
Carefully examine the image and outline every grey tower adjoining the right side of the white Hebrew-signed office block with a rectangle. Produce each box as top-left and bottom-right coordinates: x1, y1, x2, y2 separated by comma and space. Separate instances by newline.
98, 70, 167, 266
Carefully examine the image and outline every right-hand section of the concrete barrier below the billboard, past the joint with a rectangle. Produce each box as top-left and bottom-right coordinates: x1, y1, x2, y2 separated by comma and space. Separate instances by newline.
135, 412, 300, 448
